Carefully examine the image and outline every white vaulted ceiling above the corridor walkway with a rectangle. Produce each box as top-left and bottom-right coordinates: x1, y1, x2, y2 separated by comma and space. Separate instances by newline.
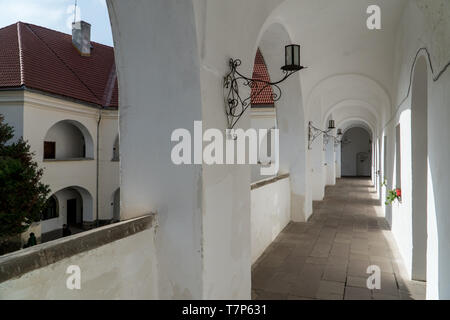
258, 0, 408, 134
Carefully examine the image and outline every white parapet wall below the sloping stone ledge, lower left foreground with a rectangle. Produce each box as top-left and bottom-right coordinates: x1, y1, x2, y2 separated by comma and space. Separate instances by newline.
0, 228, 158, 300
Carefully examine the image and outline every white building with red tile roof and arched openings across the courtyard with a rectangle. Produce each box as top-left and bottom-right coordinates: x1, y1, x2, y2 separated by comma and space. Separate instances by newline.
0, 22, 120, 242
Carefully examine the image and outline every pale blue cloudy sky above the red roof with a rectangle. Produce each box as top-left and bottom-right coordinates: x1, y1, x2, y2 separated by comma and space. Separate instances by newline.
0, 0, 113, 46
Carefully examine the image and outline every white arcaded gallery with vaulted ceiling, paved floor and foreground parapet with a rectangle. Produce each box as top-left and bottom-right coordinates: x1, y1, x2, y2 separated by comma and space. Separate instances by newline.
0, 0, 450, 300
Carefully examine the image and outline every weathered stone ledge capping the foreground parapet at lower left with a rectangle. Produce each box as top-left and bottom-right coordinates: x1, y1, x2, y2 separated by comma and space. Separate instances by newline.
0, 214, 155, 283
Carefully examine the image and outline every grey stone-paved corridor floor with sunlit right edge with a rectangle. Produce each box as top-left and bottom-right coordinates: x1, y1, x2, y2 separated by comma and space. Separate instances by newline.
252, 178, 425, 300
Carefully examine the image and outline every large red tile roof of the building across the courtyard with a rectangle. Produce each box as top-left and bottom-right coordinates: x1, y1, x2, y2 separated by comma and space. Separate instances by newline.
0, 22, 119, 107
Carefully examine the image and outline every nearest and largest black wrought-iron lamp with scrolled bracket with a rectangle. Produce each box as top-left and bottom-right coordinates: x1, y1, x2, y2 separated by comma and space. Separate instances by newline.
223, 44, 305, 129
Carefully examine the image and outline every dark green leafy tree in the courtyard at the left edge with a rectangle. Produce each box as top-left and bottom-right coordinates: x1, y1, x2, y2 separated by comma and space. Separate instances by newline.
0, 114, 50, 239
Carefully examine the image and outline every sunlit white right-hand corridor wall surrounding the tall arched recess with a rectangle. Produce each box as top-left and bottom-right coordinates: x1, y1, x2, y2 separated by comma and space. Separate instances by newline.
386, 0, 450, 299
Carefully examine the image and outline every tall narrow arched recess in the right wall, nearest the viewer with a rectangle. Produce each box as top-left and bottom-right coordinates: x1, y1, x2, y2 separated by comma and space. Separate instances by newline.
411, 56, 428, 281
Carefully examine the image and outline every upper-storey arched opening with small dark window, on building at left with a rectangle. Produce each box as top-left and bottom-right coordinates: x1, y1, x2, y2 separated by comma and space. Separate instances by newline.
43, 120, 94, 160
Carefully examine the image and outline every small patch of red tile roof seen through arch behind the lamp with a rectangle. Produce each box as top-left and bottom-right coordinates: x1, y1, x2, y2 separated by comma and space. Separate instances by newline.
251, 49, 274, 107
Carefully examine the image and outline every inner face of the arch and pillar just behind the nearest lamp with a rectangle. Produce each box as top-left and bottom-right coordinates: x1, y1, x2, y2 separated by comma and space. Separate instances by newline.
257, 22, 311, 221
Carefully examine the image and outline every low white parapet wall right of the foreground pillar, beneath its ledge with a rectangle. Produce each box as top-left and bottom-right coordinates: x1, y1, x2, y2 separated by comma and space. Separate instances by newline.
251, 178, 291, 263
